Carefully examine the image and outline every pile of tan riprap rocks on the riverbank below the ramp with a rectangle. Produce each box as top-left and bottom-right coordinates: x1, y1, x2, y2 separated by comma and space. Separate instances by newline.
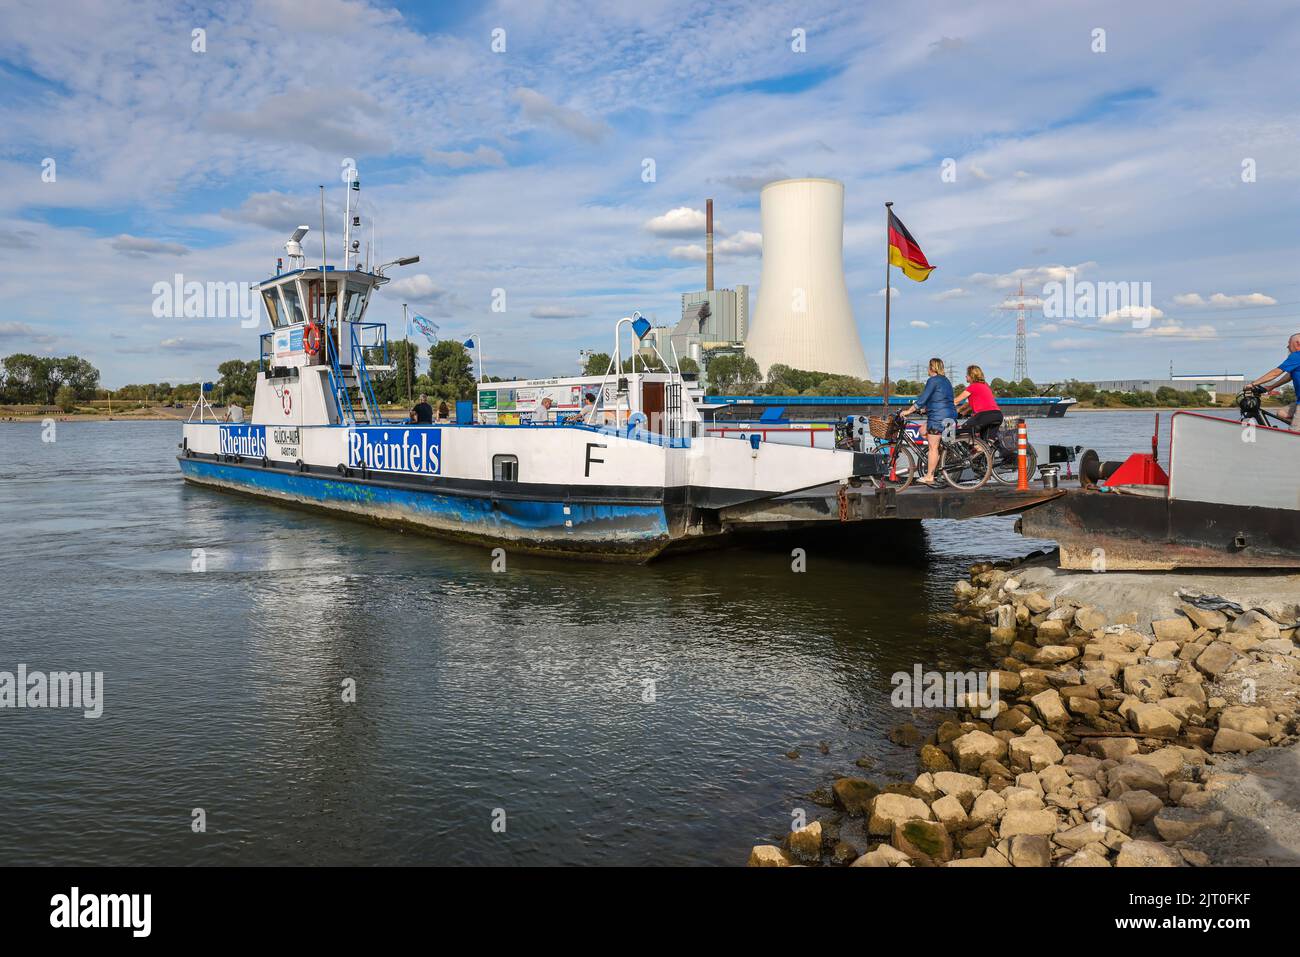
749, 563, 1300, 867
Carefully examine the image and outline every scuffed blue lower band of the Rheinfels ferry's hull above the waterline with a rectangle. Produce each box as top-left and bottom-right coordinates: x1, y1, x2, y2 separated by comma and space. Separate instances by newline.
178, 458, 670, 555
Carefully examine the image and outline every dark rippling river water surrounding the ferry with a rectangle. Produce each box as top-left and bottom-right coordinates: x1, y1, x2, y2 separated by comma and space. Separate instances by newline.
0, 412, 1227, 865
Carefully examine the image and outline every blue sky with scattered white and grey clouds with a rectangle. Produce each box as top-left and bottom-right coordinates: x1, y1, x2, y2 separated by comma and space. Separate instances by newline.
0, 0, 1300, 387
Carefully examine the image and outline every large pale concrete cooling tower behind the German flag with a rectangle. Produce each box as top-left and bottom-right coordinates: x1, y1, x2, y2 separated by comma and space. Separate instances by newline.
745, 179, 868, 378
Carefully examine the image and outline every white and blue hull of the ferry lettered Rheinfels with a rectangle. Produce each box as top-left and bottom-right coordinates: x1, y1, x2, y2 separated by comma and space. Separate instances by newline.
179, 424, 862, 562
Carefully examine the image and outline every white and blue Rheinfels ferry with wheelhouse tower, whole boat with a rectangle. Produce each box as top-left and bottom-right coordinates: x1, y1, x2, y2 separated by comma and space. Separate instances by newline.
178, 182, 879, 562
